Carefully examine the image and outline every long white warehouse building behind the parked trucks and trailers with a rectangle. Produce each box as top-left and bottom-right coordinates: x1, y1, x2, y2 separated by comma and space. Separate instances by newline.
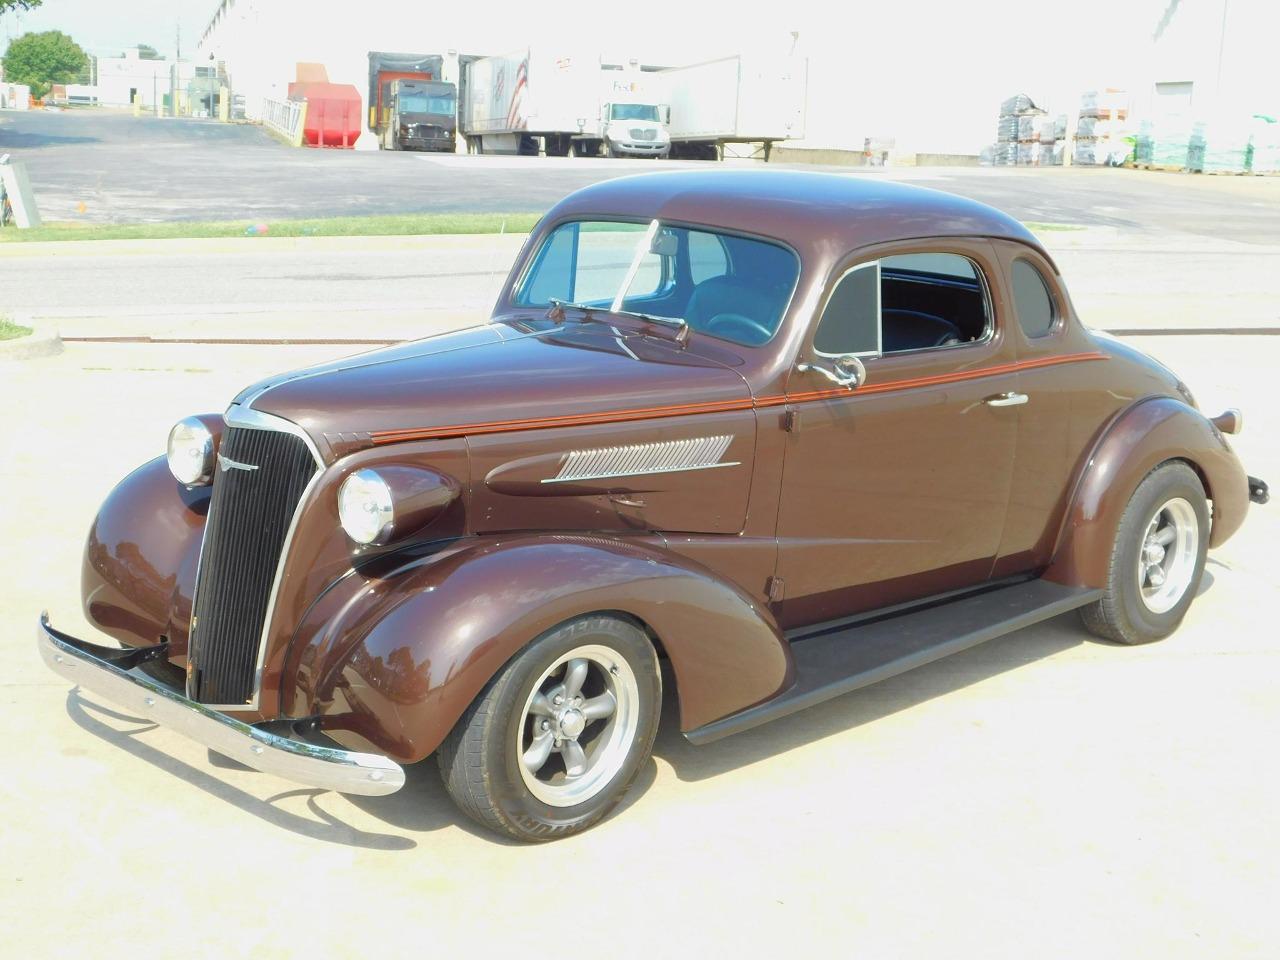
197, 0, 1277, 156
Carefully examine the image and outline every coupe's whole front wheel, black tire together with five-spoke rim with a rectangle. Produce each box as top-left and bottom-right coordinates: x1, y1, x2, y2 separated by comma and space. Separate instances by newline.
436, 616, 662, 841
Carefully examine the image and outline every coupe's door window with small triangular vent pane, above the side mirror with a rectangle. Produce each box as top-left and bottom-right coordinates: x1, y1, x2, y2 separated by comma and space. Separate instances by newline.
814, 253, 992, 355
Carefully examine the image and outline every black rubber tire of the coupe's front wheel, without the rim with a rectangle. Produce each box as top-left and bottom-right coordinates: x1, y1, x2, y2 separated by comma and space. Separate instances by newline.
436, 614, 662, 842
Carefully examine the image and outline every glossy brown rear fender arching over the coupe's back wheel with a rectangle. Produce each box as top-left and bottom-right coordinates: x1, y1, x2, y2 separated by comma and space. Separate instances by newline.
1044, 397, 1249, 588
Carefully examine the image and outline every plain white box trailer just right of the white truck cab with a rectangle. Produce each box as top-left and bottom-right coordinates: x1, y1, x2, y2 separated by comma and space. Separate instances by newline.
654, 54, 809, 160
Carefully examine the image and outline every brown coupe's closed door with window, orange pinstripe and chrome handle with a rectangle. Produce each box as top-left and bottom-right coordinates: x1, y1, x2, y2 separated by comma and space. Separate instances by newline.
776, 239, 1019, 628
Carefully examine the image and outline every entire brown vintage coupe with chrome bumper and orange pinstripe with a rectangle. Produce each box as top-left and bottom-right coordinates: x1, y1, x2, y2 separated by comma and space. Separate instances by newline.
38, 172, 1267, 840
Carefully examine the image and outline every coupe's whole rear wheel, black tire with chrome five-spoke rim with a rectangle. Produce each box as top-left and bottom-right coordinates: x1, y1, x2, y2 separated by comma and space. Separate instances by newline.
1080, 461, 1208, 644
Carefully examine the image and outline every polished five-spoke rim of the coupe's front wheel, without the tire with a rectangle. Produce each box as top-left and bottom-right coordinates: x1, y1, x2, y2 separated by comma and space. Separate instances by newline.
516, 644, 640, 806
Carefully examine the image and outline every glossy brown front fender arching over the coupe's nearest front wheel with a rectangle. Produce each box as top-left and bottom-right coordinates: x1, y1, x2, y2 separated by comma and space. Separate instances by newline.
284, 535, 792, 762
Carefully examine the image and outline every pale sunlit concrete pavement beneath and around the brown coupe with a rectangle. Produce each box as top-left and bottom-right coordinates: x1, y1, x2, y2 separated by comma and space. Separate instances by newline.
0, 337, 1280, 960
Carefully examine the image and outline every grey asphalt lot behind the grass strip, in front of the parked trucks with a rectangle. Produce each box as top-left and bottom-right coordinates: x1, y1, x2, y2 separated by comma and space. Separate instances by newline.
0, 110, 1280, 243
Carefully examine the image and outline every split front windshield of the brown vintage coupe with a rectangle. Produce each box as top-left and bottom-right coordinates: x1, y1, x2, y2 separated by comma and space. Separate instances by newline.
515, 220, 800, 346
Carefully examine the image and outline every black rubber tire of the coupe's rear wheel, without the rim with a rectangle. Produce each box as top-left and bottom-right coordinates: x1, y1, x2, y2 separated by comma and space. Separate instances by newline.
1080, 461, 1210, 644
